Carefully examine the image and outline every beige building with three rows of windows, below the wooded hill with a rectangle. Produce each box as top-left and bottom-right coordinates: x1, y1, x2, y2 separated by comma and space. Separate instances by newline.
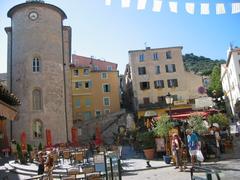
125, 46, 206, 117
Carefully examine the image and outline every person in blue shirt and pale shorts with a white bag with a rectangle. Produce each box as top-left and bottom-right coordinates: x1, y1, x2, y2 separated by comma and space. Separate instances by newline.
186, 129, 198, 167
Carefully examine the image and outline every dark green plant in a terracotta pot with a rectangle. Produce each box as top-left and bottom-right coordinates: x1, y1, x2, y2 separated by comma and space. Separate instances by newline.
137, 131, 155, 160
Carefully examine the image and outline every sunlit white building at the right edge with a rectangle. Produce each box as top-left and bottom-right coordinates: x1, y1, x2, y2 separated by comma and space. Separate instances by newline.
221, 48, 240, 115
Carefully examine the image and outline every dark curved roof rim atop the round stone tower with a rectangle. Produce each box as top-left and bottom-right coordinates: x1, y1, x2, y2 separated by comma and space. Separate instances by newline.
7, 0, 67, 19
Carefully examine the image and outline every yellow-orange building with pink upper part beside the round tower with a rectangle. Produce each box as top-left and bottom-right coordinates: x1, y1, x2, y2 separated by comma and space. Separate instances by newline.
71, 55, 120, 122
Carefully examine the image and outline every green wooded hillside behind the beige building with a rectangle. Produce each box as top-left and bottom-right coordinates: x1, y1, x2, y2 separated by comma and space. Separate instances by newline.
183, 53, 226, 76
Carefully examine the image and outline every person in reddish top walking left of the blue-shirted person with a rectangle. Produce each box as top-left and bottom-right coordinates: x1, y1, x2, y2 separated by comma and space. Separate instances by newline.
171, 133, 183, 171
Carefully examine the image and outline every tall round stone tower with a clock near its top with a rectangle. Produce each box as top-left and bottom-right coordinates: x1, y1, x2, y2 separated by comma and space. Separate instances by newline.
5, 0, 72, 145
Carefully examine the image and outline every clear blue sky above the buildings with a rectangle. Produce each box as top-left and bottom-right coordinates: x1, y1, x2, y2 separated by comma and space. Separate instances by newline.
0, 0, 240, 73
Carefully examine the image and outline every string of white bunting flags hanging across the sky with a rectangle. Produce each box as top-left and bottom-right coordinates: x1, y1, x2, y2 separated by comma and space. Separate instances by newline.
105, 0, 240, 15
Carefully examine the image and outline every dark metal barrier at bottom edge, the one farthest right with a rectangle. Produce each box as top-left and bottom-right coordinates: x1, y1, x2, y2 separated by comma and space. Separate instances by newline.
190, 166, 221, 180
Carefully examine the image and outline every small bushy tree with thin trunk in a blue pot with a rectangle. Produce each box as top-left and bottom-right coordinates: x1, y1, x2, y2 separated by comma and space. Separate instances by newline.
153, 115, 173, 164
